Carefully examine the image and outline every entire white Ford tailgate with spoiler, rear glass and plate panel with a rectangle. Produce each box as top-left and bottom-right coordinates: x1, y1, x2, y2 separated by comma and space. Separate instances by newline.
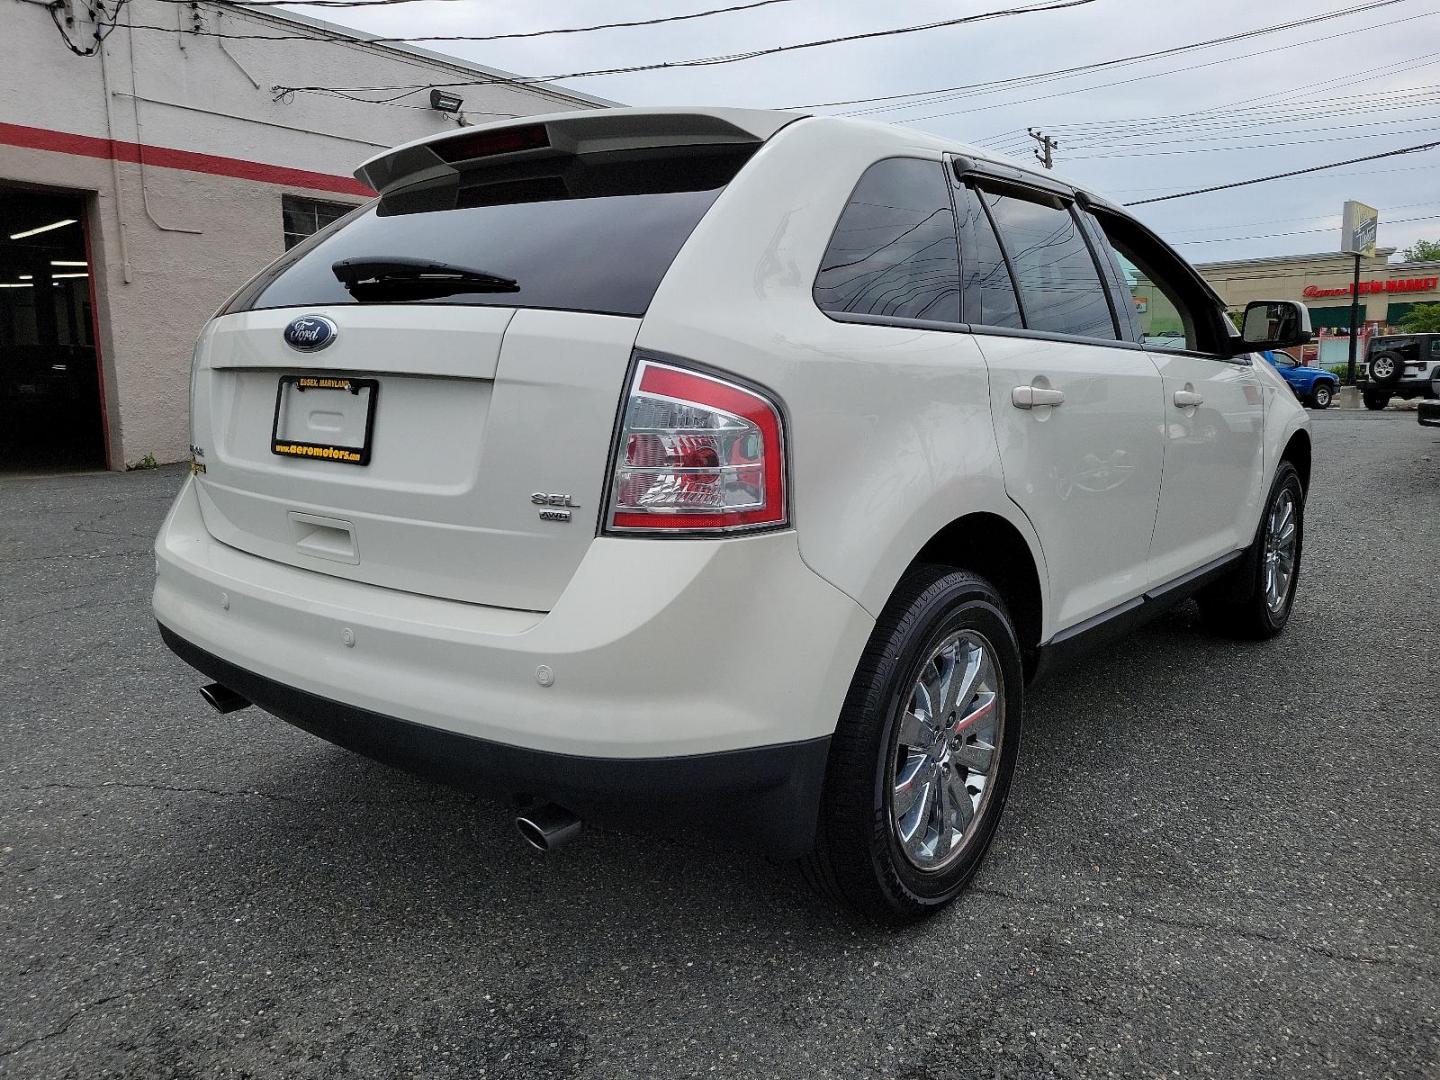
192, 109, 792, 611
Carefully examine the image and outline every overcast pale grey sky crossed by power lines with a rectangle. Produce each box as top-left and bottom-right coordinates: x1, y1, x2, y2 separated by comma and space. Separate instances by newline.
286, 0, 1440, 262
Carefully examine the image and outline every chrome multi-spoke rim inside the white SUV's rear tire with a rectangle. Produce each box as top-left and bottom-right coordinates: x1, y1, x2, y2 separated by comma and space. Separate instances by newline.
890, 629, 1005, 870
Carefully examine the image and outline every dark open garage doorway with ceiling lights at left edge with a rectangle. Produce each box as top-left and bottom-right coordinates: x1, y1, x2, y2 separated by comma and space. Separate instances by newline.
0, 189, 105, 474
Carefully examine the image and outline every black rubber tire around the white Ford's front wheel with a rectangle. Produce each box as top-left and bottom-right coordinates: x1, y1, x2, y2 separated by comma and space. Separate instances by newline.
1195, 461, 1305, 641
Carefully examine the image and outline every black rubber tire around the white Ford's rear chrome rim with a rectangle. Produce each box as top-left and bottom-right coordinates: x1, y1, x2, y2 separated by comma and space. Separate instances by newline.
802, 566, 1024, 923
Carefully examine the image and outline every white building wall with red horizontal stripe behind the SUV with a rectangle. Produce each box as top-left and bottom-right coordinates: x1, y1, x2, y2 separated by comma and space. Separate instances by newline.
0, 0, 608, 468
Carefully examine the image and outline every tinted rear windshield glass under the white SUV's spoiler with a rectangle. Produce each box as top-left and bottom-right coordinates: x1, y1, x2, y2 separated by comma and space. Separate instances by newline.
226, 145, 755, 315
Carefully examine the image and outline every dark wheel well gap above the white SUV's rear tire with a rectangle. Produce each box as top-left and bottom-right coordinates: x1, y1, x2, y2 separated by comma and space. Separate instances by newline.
912, 514, 1043, 677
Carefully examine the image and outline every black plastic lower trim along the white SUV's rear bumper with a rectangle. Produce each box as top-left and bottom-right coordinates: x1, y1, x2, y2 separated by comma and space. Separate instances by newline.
160, 625, 829, 858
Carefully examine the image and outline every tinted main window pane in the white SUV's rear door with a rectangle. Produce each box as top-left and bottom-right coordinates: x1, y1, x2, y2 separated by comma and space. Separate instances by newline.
981, 190, 1117, 338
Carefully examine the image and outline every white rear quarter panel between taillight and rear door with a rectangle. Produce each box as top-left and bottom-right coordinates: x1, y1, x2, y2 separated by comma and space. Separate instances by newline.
636, 120, 1050, 636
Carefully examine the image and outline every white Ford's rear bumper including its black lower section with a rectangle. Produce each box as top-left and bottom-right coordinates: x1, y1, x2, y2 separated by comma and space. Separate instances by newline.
154, 482, 874, 847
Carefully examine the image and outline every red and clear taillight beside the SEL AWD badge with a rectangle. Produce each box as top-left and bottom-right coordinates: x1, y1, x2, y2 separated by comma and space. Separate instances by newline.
605, 360, 786, 533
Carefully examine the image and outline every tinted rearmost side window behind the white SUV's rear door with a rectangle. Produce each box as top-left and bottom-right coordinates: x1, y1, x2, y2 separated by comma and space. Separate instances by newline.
815, 157, 960, 323
